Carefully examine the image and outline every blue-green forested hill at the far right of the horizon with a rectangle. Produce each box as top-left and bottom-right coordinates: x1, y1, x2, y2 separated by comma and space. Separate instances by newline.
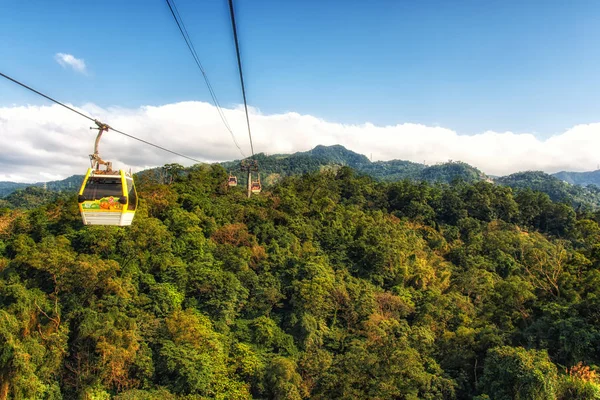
495, 171, 600, 208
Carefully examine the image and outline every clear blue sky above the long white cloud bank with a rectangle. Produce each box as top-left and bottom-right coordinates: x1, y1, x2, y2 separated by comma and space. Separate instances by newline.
0, 0, 600, 137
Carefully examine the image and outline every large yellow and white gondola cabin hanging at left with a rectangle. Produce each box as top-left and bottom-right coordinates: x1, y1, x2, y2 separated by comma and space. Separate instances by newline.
78, 168, 138, 226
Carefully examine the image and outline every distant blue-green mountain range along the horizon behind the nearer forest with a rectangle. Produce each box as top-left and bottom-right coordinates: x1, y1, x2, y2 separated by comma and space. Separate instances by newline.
0, 145, 600, 212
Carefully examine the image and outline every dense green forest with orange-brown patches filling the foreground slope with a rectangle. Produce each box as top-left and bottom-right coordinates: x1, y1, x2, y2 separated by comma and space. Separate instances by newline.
0, 165, 600, 400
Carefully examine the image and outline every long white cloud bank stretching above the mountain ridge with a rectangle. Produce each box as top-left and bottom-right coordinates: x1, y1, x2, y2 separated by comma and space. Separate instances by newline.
0, 102, 600, 182
